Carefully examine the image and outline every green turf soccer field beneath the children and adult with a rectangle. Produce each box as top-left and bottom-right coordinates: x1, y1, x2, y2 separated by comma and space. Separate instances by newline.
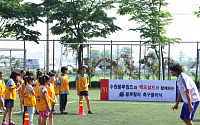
0, 88, 200, 125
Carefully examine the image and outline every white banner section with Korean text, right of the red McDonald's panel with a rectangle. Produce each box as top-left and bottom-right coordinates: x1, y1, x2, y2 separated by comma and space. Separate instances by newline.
109, 79, 176, 102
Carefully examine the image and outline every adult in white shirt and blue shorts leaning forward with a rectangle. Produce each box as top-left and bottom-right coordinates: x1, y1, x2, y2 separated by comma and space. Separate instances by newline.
170, 63, 200, 125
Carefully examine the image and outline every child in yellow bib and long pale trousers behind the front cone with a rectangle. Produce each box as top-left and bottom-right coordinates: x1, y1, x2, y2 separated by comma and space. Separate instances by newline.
24, 76, 36, 125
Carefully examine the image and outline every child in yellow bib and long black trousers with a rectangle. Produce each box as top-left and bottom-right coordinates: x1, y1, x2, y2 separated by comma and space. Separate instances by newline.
58, 66, 69, 114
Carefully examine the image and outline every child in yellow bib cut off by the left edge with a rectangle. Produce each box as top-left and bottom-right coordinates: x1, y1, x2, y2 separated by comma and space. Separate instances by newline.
0, 72, 6, 111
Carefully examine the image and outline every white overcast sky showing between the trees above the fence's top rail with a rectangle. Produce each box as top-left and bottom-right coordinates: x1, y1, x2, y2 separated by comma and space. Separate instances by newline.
19, 0, 200, 41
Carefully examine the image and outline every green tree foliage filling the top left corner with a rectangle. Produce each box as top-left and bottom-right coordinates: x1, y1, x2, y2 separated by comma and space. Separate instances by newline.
0, 0, 42, 43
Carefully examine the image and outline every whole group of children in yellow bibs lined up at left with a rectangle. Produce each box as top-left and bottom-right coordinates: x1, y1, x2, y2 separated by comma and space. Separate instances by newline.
0, 66, 93, 125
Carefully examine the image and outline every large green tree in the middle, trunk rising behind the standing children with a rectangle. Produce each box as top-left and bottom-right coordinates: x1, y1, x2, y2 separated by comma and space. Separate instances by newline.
49, 0, 120, 71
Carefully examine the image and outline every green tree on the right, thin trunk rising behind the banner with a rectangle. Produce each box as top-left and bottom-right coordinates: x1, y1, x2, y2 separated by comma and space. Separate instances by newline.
118, 0, 180, 78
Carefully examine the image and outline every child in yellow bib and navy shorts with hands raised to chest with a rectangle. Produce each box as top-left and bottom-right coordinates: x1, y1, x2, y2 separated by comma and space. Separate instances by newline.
2, 71, 20, 125
